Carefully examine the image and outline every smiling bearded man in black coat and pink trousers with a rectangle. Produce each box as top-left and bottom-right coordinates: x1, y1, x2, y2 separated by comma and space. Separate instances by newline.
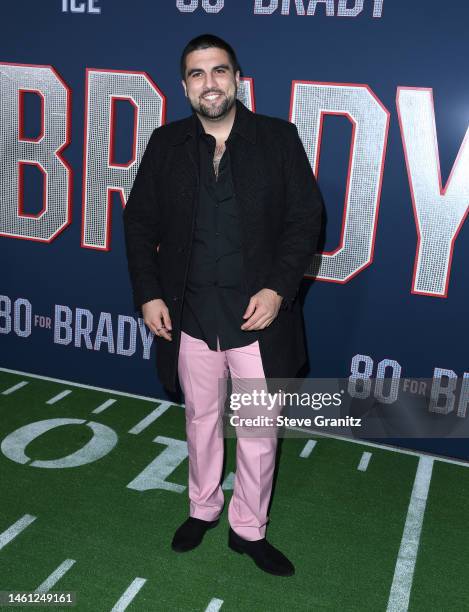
124, 34, 323, 576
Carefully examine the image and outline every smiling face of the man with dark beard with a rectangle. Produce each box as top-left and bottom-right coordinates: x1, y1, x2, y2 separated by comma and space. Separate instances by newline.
182, 47, 239, 120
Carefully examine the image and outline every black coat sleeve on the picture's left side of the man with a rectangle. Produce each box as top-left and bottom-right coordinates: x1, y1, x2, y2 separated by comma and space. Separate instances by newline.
123, 130, 162, 311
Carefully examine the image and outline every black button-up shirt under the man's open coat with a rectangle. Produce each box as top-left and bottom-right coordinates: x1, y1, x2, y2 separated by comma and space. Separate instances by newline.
181, 117, 258, 351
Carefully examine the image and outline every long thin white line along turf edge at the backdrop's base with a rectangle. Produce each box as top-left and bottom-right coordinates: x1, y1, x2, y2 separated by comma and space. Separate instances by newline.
0, 367, 469, 468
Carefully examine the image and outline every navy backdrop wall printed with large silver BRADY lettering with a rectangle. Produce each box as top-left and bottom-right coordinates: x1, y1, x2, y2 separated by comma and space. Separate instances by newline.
0, 0, 469, 458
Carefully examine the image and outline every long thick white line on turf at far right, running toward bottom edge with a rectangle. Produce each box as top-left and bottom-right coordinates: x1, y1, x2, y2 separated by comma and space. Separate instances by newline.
387, 457, 434, 612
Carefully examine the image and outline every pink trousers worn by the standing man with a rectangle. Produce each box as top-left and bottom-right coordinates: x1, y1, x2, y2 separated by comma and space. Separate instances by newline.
178, 332, 277, 540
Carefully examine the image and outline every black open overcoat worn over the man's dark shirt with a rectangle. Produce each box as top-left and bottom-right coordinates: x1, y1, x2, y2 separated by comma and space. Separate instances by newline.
123, 100, 323, 391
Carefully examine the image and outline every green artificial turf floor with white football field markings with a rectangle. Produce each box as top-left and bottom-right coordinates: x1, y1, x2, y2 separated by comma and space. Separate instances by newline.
0, 371, 469, 612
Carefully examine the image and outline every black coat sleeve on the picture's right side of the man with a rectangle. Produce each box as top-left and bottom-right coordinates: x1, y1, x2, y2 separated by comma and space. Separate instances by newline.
265, 123, 324, 309
